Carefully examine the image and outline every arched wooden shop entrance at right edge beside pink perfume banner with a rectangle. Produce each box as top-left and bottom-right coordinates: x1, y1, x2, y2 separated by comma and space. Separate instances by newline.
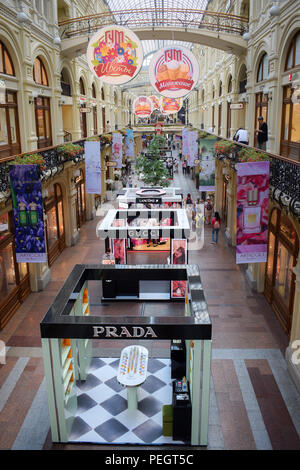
264, 209, 299, 335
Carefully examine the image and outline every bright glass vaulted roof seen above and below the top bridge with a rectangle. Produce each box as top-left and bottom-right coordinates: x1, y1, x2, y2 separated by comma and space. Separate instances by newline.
106, 0, 210, 67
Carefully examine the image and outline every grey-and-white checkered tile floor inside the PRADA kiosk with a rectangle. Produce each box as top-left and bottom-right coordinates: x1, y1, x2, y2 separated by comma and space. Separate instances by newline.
69, 358, 183, 445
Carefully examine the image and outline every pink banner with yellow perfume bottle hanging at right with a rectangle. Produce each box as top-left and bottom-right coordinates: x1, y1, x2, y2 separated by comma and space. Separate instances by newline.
236, 161, 270, 264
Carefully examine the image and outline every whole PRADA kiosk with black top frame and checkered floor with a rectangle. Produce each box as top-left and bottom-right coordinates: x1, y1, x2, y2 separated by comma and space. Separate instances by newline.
40, 265, 212, 446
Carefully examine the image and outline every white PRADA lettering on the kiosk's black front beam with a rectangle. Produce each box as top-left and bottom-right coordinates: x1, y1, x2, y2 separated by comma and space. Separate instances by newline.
93, 325, 157, 339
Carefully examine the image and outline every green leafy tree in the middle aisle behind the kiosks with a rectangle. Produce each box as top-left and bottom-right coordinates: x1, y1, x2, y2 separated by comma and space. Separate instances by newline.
135, 135, 170, 187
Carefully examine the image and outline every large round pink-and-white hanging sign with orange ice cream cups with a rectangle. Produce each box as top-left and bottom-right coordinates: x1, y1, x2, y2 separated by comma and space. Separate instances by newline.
149, 46, 199, 98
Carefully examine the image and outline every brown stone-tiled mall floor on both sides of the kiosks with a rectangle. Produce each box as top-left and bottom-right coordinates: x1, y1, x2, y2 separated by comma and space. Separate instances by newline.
0, 162, 300, 450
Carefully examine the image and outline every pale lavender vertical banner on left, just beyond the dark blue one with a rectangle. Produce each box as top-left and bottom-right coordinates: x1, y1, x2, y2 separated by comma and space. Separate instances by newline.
84, 140, 101, 194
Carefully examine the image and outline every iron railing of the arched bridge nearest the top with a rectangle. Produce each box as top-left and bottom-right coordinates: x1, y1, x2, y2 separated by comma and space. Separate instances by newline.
58, 8, 249, 39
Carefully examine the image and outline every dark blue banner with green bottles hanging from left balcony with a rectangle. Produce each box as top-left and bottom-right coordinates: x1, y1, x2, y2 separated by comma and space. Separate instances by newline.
9, 165, 47, 263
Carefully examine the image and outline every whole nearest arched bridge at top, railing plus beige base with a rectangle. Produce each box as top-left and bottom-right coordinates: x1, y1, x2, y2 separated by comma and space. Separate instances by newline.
59, 8, 248, 59
